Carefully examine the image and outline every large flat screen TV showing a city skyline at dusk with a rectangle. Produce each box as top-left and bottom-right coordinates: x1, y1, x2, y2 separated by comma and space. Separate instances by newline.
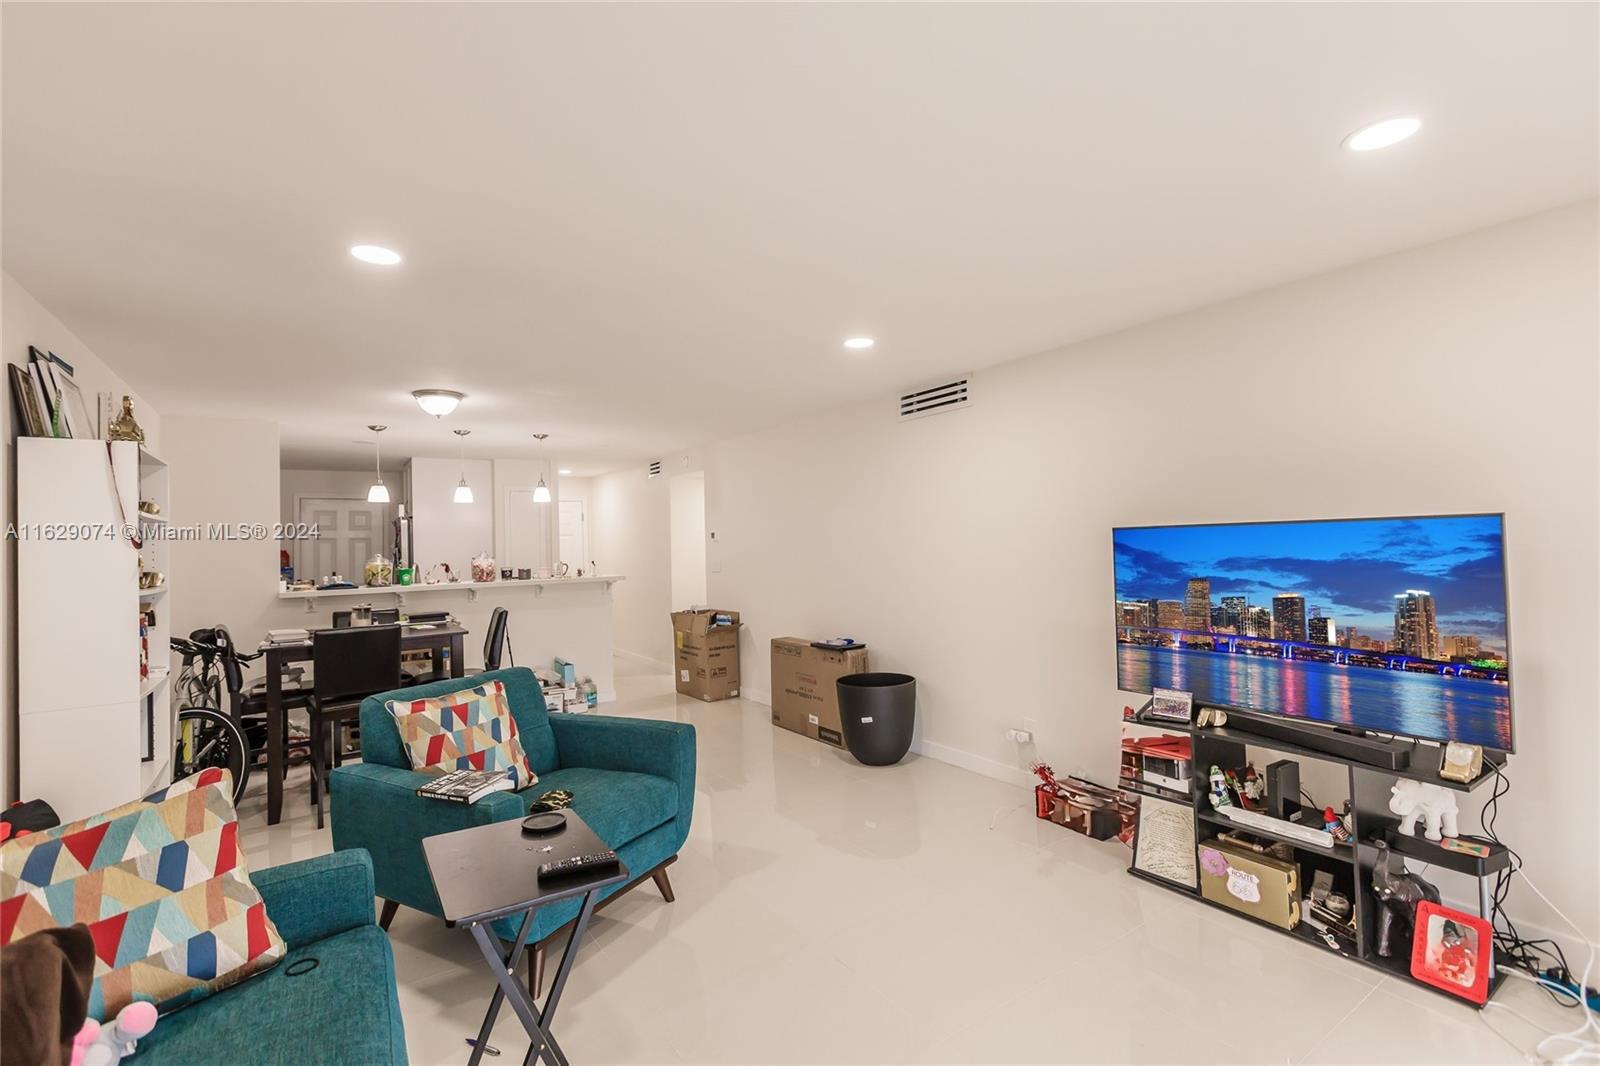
1112, 514, 1512, 752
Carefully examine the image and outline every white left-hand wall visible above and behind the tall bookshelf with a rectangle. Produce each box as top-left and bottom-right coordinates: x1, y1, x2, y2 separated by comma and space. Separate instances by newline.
0, 274, 163, 802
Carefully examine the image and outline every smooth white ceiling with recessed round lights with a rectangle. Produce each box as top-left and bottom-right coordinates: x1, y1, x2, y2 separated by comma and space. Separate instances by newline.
3, 3, 1600, 472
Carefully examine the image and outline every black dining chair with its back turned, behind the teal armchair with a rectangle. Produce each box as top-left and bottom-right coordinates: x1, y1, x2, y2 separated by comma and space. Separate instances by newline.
310, 626, 400, 829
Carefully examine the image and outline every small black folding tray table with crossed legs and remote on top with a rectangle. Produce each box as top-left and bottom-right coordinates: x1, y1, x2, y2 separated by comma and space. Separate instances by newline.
422, 800, 627, 1066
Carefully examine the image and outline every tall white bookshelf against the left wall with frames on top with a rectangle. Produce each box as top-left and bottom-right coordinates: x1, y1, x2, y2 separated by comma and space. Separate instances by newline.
16, 437, 173, 821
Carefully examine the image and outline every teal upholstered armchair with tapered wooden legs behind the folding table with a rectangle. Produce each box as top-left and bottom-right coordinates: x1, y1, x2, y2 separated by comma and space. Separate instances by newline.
328, 667, 694, 996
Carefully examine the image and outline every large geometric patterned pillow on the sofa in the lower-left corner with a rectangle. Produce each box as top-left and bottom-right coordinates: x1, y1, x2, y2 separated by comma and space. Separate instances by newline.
0, 768, 285, 1021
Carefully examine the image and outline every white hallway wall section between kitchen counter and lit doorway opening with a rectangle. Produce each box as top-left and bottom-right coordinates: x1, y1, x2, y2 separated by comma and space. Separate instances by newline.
589, 467, 672, 669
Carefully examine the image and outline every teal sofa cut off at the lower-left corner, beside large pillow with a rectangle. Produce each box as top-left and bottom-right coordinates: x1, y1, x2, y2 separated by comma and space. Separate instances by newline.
123, 852, 406, 1066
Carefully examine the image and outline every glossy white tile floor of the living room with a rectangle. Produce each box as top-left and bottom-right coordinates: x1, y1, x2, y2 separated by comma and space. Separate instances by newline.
240, 663, 1578, 1066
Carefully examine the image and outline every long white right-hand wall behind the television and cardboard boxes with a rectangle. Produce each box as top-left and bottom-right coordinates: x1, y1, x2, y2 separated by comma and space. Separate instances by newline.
710, 202, 1600, 936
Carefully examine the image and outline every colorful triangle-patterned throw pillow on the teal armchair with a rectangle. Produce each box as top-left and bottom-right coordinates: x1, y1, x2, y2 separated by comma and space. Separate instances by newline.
386, 680, 539, 789
